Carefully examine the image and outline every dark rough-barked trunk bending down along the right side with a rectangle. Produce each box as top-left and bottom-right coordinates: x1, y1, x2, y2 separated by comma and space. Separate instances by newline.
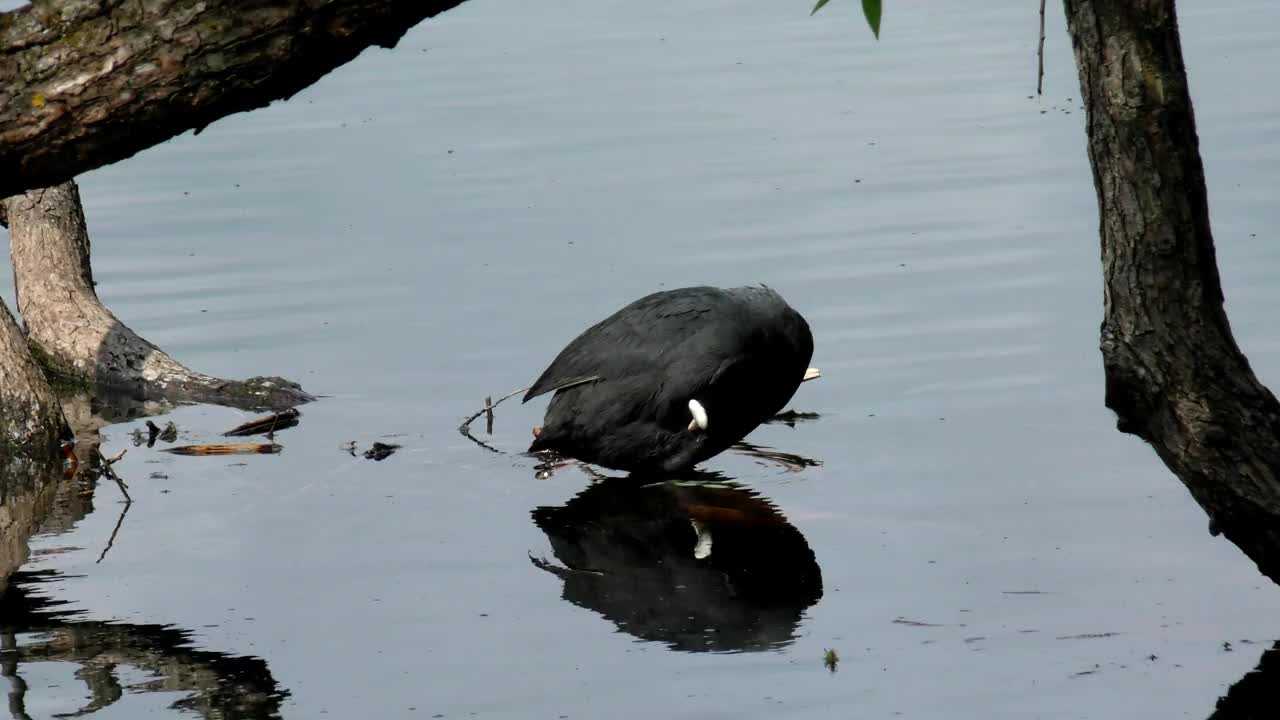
1065, 0, 1280, 582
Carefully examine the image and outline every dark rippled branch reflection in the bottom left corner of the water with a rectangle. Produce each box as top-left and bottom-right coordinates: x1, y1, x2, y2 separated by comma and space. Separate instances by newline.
0, 571, 288, 719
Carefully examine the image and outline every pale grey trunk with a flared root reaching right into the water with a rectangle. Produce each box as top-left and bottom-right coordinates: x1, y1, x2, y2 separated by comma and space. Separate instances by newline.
0, 181, 312, 409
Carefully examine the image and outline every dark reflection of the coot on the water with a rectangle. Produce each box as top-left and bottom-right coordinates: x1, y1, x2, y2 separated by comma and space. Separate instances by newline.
531, 473, 822, 652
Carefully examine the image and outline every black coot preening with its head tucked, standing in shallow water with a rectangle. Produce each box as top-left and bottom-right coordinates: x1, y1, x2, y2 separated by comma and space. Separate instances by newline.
524, 286, 819, 473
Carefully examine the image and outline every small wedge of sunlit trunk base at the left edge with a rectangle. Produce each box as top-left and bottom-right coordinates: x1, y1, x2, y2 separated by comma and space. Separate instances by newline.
0, 300, 70, 458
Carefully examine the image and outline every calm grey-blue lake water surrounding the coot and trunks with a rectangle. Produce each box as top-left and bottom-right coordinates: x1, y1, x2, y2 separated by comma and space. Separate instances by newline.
0, 0, 1280, 719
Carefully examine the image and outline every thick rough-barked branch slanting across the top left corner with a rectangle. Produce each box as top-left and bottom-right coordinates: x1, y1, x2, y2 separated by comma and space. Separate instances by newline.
0, 0, 462, 197
